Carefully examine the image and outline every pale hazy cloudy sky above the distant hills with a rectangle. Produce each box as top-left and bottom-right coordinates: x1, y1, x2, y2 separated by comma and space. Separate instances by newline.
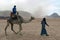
0, 0, 60, 16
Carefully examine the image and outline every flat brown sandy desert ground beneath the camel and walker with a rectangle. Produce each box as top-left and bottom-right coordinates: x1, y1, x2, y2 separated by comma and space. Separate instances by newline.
0, 19, 60, 40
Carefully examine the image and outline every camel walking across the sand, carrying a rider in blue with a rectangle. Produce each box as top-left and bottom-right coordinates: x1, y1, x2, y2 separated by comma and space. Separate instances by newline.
5, 15, 34, 35
